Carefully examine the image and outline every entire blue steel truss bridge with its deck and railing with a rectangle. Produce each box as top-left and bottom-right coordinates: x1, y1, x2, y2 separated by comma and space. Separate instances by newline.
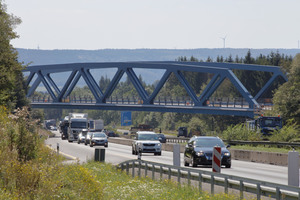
24, 62, 287, 118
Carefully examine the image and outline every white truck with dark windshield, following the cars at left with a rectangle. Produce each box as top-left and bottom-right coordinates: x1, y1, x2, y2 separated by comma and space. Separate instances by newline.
68, 113, 89, 142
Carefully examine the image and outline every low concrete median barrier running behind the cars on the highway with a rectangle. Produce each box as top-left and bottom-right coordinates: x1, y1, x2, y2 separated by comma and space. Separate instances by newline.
108, 137, 292, 166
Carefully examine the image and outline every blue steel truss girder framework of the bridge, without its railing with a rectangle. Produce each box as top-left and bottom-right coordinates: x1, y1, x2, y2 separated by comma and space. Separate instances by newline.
24, 62, 287, 117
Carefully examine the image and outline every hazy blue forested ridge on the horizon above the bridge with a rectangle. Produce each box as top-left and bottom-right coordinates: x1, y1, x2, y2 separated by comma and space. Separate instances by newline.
17, 48, 300, 65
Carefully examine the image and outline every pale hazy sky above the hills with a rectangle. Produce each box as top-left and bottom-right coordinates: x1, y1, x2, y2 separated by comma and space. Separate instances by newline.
2, 0, 300, 50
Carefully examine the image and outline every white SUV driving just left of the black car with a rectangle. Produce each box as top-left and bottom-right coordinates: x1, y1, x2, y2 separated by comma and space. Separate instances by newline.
132, 131, 162, 156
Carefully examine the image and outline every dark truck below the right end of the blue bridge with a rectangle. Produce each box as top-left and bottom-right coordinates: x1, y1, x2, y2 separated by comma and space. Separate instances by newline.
246, 115, 283, 136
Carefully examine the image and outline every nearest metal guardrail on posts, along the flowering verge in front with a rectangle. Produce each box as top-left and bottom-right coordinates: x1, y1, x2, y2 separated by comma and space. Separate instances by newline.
117, 160, 300, 199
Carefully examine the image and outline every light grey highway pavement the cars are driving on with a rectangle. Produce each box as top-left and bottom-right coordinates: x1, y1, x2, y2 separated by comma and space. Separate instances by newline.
46, 131, 288, 185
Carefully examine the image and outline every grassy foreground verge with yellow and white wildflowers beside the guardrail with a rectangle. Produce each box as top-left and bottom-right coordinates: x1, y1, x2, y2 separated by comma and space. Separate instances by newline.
0, 158, 248, 200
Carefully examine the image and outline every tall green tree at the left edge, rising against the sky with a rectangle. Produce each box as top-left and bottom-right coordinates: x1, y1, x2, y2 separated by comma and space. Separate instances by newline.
0, 0, 27, 109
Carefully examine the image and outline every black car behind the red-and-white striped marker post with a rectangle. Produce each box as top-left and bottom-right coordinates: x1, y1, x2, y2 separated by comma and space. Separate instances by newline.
184, 136, 231, 168
